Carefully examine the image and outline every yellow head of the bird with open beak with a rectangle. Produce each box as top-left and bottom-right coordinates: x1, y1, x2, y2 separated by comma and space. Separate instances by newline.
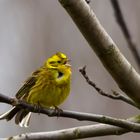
45, 52, 70, 69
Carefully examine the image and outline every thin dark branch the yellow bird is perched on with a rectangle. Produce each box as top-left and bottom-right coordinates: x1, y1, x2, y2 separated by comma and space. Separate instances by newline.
0, 94, 140, 132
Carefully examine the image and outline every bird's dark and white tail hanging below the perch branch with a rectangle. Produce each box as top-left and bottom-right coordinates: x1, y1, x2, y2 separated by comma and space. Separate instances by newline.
0, 107, 31, 127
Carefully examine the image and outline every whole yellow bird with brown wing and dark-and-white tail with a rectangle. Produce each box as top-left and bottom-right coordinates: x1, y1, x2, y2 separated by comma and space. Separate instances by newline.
0, 52, 71, 127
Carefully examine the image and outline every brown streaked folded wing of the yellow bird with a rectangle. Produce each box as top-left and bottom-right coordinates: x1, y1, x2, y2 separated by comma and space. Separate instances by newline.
16, 70, 40, 99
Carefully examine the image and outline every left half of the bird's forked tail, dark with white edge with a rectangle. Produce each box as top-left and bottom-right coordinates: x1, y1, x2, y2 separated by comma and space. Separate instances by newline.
0, 107, 20, 121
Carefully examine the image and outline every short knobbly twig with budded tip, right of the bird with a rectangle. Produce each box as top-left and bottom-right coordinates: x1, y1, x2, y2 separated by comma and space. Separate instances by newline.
79, 66, 140, 109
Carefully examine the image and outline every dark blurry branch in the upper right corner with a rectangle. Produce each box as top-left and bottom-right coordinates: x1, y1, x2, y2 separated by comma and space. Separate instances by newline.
111, 0, 140, 69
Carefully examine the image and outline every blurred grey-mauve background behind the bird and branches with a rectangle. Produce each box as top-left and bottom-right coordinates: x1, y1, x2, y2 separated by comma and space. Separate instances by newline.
0, 0, 140, 140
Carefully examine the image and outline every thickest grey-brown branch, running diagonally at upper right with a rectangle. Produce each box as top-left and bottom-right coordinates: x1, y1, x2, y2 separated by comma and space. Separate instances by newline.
59, 0, 140, 106
